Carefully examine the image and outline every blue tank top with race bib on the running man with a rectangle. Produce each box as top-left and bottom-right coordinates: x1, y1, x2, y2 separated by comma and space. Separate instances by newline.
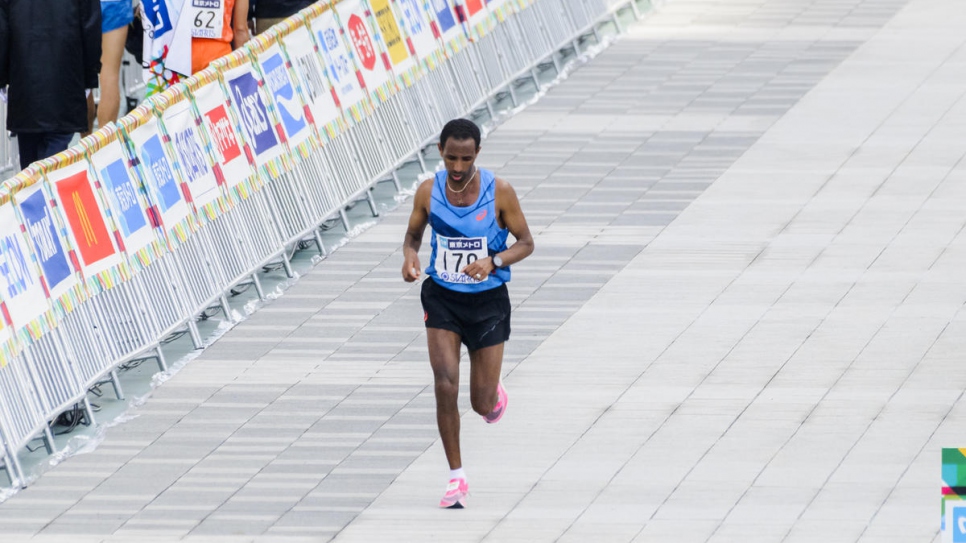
426, 168, 510, 292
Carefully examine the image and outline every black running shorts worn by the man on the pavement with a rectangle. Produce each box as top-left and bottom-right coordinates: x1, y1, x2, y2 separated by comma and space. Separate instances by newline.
420, 278, 510, 351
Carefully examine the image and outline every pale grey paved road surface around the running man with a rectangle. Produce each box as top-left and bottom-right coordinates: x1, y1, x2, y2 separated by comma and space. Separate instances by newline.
0, 0, 966, 543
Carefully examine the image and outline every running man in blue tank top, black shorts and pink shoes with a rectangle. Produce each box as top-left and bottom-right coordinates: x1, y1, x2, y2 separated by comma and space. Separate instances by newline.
402, 119, 533, 509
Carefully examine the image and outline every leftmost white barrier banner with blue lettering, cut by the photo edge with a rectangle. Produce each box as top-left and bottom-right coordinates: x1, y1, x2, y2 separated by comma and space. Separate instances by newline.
0, 198, 49, 339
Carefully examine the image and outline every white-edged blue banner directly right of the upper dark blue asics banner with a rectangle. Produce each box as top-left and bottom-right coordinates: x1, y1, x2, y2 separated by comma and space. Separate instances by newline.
252, 41, 314, 153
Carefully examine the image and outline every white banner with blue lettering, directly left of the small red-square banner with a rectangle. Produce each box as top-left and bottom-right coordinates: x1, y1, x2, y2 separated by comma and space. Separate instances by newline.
159, 99, 222, 211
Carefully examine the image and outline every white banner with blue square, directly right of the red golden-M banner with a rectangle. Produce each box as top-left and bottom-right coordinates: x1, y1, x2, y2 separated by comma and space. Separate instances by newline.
87, 130, 162, 268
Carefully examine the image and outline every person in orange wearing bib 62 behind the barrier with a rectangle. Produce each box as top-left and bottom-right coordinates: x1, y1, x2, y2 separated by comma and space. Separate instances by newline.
192, 0, 250, 73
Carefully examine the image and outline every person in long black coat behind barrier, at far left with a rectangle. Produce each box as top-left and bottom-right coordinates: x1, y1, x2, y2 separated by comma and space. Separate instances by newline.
0, 0, 101, 168
